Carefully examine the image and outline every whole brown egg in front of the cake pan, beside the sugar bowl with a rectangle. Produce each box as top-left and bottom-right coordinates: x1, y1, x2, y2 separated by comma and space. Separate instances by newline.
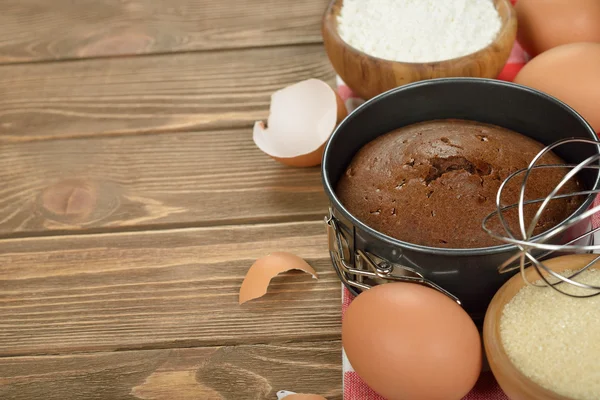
342, 282, 482, 400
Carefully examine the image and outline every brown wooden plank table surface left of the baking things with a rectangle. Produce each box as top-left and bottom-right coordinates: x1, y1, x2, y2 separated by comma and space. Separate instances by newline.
0, 0, 342, 400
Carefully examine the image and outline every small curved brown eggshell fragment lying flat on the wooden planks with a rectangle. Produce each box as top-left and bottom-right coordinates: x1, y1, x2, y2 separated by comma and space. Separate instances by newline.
239, 252, 318, 304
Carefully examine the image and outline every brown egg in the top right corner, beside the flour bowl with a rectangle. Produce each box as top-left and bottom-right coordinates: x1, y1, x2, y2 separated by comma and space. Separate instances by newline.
515, 0, 600, 57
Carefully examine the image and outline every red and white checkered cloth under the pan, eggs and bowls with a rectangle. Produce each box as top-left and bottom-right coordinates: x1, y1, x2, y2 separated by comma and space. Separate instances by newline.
337, 0, 600, 400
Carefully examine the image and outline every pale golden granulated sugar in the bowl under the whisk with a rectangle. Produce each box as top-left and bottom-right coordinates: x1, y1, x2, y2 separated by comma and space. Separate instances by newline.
500, 269, 600, 400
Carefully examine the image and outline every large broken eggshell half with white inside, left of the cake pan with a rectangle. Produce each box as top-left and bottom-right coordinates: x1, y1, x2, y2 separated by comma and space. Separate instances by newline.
252, 79, 348, 167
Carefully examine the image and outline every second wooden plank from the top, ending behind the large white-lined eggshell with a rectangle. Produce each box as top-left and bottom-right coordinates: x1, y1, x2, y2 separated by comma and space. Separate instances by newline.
0, 45, 334, 142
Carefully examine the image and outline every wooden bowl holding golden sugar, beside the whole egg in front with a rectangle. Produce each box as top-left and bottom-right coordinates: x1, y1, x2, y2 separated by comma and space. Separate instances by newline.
483, 254, 598, 400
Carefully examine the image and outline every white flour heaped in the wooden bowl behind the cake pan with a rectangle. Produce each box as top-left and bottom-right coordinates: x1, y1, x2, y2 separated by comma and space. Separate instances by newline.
338, 0, 502, 62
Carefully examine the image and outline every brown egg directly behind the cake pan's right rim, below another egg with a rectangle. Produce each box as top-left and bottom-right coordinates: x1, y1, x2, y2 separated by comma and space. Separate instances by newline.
514, 42, 600, 132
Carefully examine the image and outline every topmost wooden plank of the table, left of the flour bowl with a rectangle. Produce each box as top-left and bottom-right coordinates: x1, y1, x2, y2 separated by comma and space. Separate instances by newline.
0, 0, 327, 63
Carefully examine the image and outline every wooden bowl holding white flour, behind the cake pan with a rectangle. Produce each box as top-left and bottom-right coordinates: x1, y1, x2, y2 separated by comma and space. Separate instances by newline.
322, 0, 517, 99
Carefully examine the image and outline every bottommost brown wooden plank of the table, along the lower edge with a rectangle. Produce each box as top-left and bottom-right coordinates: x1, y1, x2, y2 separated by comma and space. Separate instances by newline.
0, 341, 342, 400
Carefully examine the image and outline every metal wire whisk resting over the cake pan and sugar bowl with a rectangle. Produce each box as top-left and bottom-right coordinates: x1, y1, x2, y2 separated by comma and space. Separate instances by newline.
482, 138, 600, 298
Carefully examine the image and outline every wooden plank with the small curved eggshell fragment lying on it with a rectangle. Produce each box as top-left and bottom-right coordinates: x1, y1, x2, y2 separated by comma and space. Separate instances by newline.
0, 222, 341, 356
